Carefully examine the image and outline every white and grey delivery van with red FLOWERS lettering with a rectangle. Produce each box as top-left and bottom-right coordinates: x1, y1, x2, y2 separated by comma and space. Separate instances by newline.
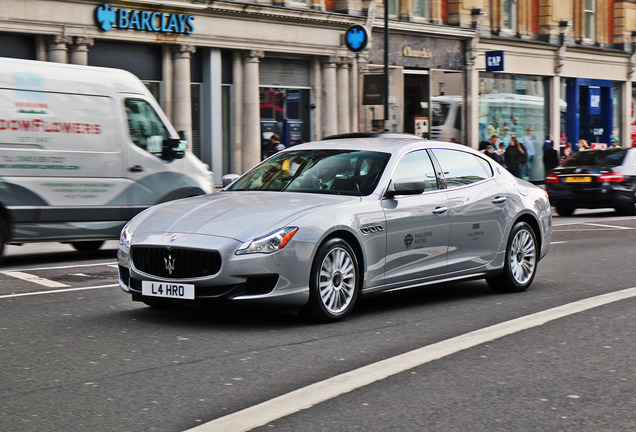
0, 58, 213, 260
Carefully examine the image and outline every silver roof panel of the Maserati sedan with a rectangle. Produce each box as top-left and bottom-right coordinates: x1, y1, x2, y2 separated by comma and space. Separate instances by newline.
287, 133, 472, 157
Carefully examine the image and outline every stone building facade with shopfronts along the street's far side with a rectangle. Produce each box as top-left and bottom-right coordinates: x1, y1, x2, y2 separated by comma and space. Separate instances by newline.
0, 0, 636, 185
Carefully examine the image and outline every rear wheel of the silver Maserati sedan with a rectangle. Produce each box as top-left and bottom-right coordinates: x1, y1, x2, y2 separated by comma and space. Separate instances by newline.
486, 222, 539, 292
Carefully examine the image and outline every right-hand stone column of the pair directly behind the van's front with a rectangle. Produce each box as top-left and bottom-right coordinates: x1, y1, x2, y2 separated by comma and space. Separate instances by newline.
172, 45, 195, 143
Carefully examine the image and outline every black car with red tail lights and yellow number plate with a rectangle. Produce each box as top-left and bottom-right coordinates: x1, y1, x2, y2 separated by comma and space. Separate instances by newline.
545, 148, 636, 216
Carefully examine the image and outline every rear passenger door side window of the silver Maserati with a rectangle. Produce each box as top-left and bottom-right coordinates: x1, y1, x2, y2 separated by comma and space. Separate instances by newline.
433, 149, 492, 189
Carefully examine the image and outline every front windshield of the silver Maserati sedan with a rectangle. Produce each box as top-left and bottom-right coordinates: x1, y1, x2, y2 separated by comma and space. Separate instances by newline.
226, 150, 390, 196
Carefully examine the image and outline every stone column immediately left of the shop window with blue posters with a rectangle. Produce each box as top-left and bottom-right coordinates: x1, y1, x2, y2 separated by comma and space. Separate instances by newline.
243, 50, 265, 171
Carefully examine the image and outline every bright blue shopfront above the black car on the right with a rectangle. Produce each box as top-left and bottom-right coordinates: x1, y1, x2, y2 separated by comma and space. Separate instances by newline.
561, 78, 615, 146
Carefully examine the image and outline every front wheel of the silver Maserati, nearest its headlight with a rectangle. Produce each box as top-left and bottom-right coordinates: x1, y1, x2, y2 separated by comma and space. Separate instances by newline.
303, 238, 360, 322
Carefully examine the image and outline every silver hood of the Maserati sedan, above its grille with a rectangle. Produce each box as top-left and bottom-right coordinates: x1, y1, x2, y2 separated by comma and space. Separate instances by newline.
131, 191, 360, 242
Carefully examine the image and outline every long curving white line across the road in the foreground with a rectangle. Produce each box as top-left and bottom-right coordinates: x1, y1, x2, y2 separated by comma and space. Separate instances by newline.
186, 287, 636, 432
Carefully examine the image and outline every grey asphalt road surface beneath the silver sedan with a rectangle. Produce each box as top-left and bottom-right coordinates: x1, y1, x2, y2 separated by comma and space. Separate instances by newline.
0, 212, 636, 431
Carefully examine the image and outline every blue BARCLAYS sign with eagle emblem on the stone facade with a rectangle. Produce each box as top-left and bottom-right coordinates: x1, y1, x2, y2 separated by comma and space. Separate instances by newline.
95, 4, 194, 34
